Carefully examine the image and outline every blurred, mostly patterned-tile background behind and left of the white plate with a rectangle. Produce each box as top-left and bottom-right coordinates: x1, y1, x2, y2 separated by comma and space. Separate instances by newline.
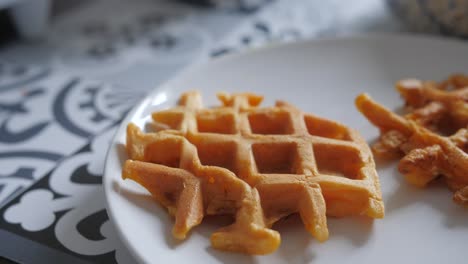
0, 0, 468, 263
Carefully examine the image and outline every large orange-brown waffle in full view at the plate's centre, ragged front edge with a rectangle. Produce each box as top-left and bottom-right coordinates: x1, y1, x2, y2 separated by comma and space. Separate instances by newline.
122, 92, 384, 254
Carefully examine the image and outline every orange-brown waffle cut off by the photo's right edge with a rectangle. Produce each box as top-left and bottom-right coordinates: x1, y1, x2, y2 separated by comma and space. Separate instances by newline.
356, 75, 468, 206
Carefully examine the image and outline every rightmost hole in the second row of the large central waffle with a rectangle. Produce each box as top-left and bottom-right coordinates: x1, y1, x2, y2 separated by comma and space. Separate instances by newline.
313, 144, 364, 179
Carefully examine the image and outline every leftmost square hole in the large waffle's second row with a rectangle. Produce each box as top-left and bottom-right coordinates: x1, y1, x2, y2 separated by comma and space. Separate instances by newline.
145, 139, 182, 168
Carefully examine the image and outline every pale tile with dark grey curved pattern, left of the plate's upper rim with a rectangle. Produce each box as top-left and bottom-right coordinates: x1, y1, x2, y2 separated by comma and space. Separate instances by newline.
0, 62, 143, 204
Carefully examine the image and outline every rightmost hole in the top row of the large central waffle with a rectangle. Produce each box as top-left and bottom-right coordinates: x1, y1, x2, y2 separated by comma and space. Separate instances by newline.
304, 115, 350, 140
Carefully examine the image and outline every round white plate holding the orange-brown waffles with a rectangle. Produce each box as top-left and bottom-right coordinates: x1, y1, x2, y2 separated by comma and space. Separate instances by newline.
104, 35, 468, 264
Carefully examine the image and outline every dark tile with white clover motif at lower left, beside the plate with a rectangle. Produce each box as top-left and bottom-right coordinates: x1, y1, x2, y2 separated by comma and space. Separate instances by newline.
0, 127, 134, 263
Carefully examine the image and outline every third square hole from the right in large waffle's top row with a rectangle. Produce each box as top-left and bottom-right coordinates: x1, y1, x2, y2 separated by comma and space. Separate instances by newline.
197, 112, 237, 134
